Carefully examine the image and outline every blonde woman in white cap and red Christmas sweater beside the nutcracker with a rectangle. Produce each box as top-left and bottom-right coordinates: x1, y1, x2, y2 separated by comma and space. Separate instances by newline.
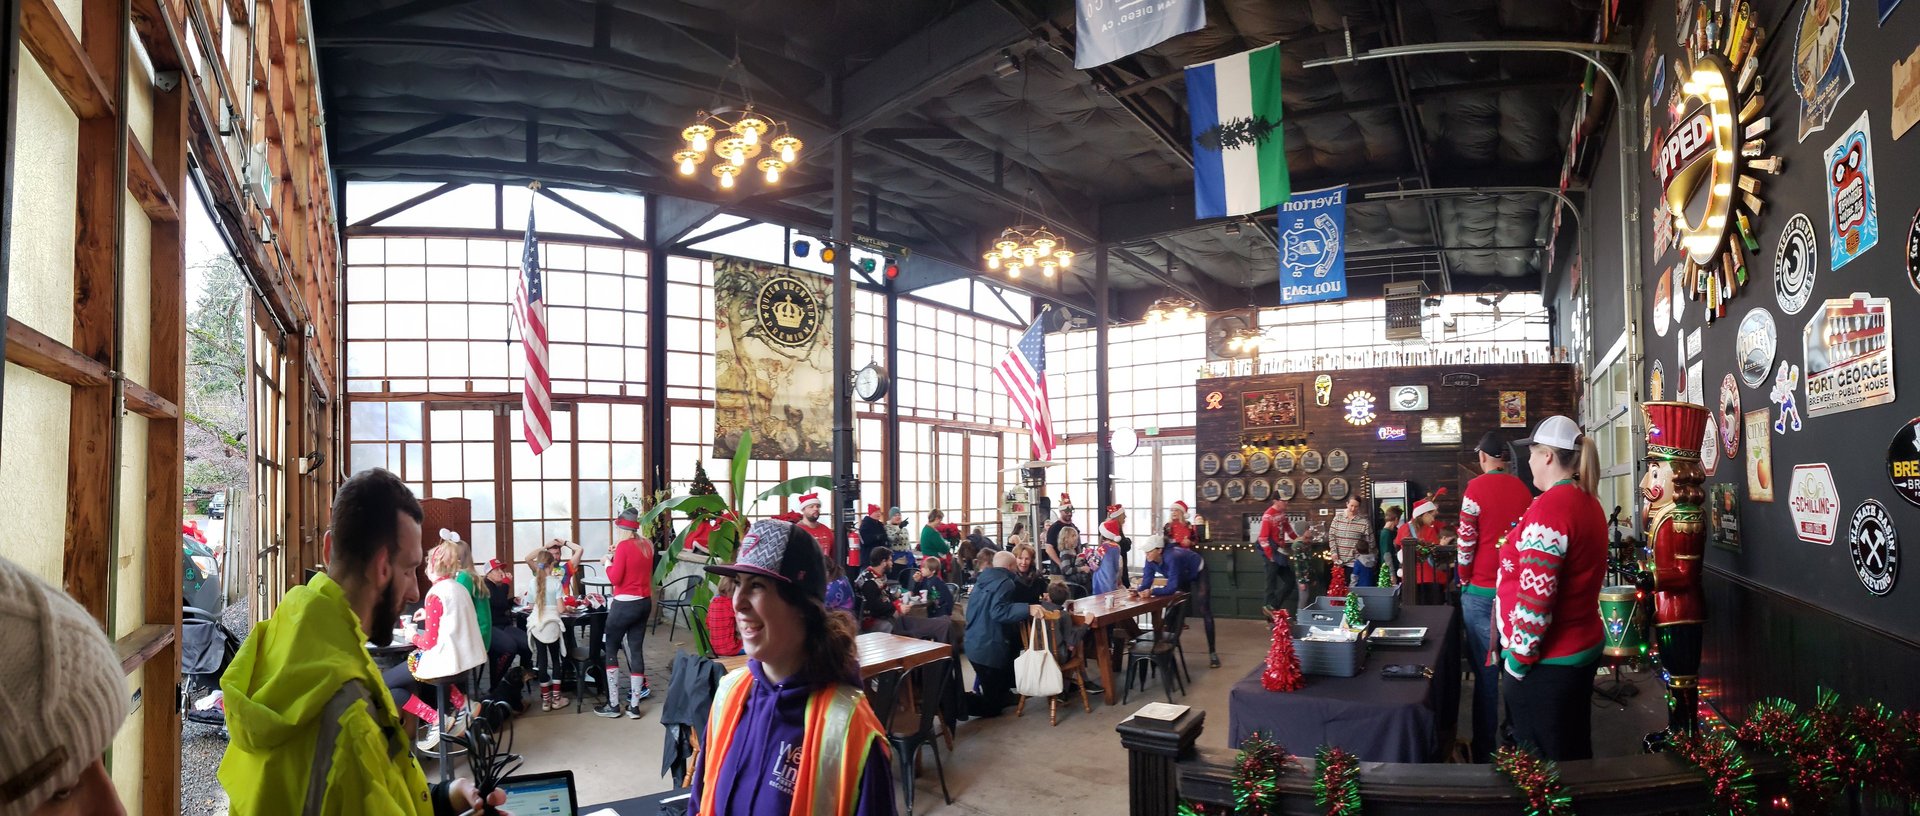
1494, 417, 1607, 762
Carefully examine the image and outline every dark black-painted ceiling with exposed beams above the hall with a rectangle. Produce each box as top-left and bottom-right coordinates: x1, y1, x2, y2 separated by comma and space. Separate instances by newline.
315, 0, 1597, 307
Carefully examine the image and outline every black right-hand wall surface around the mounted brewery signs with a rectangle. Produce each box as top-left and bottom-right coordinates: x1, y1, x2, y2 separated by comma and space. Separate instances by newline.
1628, 0, 1920, 712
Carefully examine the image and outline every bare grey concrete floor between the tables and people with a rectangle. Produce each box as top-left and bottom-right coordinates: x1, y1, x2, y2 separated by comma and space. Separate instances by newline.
456, 620, 1665, 816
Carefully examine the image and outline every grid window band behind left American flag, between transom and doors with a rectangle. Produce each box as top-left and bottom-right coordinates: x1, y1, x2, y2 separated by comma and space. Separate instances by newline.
346, 236, 647, 396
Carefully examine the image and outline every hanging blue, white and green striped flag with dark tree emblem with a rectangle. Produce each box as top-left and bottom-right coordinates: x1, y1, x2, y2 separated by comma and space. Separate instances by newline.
1187, 42, 1290, 219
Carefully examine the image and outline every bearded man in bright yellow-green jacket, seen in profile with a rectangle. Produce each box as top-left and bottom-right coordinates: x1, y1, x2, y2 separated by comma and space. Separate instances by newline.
219, 468, 507, 816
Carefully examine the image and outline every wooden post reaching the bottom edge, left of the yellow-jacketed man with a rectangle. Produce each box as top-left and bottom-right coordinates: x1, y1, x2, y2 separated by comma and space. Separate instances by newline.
140, 68, 186, 814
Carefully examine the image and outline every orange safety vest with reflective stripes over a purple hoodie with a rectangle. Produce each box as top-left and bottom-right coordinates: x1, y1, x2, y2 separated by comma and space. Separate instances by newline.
699, 668, 887, 816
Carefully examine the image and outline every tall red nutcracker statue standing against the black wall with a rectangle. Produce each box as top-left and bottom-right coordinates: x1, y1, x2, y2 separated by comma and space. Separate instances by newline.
1640, 401, 1713, 749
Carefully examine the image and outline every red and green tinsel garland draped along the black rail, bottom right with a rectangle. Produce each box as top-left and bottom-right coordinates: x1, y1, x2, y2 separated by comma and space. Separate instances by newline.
1179, 687, 1920, 816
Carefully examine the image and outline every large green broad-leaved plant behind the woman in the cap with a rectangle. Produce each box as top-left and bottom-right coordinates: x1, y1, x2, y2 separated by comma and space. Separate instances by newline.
639, 430, 833, 653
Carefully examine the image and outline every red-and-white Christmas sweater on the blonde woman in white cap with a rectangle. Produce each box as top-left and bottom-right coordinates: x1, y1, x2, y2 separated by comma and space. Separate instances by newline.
1494, 482, 1607, 678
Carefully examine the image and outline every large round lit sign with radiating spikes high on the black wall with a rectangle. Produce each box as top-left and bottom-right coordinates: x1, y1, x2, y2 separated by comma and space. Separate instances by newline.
1653, 2, 1782, 323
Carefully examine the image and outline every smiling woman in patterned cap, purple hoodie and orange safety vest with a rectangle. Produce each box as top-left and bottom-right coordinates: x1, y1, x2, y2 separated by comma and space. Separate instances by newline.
687, 520, 895, 816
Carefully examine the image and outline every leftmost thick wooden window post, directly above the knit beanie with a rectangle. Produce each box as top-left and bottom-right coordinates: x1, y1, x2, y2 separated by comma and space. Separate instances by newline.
61, 0, 132, 618
